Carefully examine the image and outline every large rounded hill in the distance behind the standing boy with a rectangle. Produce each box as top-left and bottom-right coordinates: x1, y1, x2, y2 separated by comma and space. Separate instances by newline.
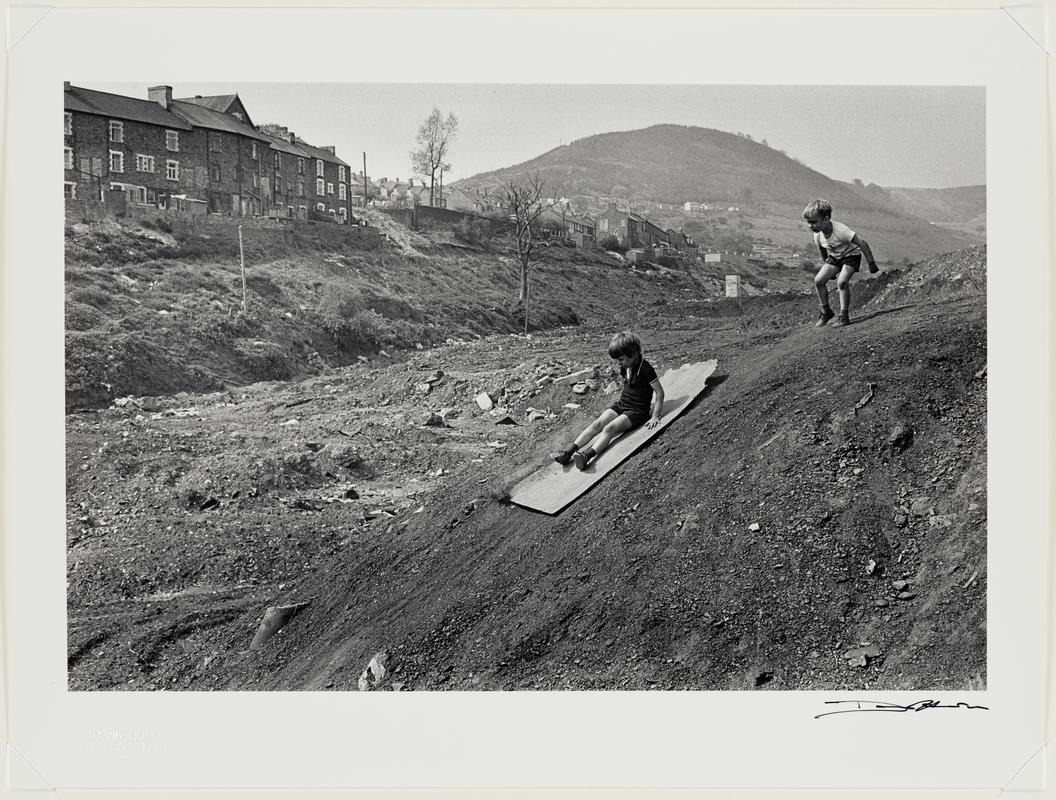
455, 125, 982, 261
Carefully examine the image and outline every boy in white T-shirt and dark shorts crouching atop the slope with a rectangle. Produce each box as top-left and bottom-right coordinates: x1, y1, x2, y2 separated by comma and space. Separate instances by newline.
803, 199, 880, 327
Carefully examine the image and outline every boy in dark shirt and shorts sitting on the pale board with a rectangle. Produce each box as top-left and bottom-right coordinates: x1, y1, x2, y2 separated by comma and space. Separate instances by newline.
553, 330, 663, 470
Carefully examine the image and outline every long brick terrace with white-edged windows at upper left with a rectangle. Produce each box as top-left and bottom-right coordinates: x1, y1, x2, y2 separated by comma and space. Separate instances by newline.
63, 82, 364, 223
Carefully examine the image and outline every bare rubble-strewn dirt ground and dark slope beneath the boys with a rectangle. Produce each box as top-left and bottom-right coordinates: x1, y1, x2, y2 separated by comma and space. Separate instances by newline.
67, 229, 986, 690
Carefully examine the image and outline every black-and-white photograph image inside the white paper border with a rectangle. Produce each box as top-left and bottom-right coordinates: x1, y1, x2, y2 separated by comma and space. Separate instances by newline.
63, 79, 987, 691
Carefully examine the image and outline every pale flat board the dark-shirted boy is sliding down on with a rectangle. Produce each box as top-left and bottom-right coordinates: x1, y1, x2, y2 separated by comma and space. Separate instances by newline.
510, 359, 718, 514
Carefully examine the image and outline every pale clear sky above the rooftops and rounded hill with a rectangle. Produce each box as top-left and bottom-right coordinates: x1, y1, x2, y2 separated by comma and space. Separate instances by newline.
88, 83, 986, 188
